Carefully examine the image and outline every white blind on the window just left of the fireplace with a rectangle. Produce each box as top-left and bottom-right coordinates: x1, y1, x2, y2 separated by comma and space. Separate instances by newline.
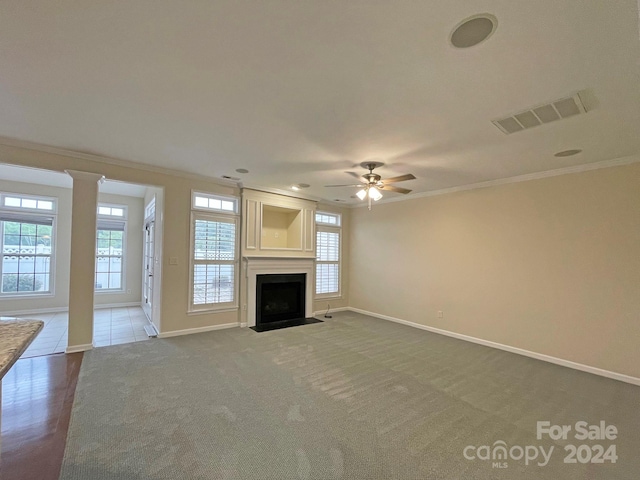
191, 212, 237, 310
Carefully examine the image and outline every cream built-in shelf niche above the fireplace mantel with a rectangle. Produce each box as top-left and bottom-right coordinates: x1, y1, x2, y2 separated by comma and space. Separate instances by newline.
242, 189, 316, 257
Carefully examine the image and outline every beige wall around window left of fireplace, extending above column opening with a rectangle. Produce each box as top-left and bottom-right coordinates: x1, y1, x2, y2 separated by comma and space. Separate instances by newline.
0, 145, 239, 333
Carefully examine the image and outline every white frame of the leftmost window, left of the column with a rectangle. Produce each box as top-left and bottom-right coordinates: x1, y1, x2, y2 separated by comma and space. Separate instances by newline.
0, 191, 58, 299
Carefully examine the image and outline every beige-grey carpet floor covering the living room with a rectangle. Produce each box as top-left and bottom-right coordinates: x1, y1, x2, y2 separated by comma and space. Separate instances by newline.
60, 312, 640, 480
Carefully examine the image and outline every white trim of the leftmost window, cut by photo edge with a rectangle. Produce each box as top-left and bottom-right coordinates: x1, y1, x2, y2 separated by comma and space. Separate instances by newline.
0, 191, 58, 300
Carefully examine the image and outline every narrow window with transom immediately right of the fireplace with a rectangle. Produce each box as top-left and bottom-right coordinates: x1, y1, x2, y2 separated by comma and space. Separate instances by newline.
316, 212, 342, 297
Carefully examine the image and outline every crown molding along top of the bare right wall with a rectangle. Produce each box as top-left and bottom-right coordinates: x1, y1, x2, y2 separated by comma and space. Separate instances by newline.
349, 155, 640, 208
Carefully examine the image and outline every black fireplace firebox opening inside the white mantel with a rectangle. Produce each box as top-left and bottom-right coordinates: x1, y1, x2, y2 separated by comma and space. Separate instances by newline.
256, 273, 306, 326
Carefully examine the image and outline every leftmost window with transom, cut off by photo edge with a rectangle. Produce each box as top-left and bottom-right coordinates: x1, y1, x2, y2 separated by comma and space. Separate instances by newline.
0, 193, 56, 296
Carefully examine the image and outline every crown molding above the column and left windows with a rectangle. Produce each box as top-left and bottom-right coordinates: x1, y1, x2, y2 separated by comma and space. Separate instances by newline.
0, 136, 240, 188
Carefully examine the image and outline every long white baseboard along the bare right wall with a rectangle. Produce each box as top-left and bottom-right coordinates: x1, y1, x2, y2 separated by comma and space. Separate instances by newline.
346, 307, 640, 386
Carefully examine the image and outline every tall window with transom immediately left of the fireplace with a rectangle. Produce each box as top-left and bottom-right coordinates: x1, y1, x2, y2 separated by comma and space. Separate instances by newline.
189, 193, 238, 312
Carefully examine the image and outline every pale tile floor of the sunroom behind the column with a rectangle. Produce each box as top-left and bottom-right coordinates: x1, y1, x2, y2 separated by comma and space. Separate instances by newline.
20, 307, 149, 358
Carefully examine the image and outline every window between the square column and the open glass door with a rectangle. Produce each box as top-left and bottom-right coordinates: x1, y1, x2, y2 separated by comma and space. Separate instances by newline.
95, 204, 127, 292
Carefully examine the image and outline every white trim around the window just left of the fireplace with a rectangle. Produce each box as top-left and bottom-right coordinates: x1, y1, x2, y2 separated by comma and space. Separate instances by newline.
187, 211, 240, 315
